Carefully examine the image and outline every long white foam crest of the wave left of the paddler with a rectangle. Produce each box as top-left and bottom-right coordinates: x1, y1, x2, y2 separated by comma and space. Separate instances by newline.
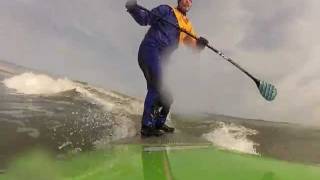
3, 72, 142, 114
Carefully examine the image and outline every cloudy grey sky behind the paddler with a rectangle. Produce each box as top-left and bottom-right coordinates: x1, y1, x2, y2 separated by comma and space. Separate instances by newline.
0, 0, 320, 125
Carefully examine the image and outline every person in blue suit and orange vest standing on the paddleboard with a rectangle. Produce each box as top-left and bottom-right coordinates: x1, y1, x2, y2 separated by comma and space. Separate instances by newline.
126, 0, 208, 137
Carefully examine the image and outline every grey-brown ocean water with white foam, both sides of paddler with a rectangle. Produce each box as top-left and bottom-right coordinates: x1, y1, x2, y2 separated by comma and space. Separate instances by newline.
0, 62, 320, 170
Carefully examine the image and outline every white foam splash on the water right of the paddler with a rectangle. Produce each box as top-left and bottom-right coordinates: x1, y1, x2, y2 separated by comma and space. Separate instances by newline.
203, 122, 259, 155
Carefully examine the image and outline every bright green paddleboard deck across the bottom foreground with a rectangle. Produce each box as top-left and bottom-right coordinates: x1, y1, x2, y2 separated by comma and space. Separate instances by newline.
0, 133, 320, 180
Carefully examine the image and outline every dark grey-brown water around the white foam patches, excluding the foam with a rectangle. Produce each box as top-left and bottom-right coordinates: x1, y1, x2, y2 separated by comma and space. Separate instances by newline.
0, 62, 320, 173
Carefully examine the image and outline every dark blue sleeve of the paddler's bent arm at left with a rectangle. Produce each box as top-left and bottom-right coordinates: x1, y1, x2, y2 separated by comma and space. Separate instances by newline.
128, 5, 171, 26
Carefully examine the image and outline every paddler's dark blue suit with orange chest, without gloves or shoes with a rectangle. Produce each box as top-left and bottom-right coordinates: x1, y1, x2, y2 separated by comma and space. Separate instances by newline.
128, 5, 198, 127
